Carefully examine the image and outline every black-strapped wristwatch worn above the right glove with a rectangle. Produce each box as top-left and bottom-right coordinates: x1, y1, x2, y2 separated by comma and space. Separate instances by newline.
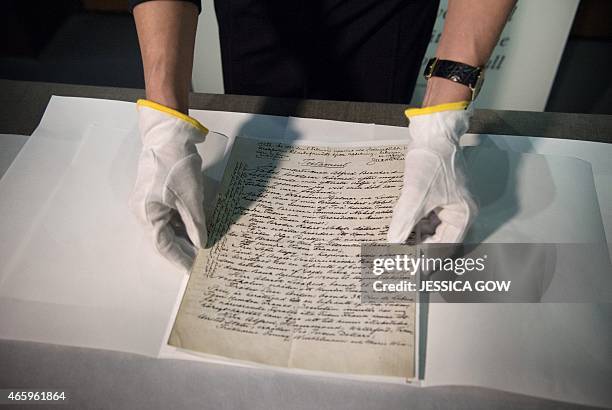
423, 57, 484, 101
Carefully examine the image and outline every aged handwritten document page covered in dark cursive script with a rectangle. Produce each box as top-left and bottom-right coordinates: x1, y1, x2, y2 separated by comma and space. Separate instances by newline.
169, 138, 415, 378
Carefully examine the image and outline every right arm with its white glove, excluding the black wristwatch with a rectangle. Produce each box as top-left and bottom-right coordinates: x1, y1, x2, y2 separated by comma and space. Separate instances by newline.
387, 0, 515, 243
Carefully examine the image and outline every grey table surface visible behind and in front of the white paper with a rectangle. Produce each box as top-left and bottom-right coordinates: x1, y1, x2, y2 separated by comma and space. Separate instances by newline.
0, 80, 612, 409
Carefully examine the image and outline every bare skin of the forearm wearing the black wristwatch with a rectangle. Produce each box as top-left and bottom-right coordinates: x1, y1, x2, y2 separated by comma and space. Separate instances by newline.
423, 0, 516, 107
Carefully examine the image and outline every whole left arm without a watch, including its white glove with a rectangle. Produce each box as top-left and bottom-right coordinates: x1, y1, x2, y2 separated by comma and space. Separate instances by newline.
129, 0, 208, 270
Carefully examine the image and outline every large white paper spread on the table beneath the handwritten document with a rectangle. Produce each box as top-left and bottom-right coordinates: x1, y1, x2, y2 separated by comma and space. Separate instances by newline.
0, 97, 612, 404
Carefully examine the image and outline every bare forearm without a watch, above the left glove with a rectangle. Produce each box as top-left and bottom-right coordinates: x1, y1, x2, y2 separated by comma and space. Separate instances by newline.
133, 1, 198, 113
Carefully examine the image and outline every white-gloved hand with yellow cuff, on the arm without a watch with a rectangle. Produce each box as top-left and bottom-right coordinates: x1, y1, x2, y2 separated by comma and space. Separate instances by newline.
129, 100, 208, 269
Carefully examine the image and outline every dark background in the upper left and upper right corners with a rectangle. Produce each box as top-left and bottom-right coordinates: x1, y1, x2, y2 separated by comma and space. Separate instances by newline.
0, 0, 612, 114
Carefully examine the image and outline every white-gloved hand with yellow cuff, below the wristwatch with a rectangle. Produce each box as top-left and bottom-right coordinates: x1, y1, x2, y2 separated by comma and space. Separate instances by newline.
387, 101, 478, 243
